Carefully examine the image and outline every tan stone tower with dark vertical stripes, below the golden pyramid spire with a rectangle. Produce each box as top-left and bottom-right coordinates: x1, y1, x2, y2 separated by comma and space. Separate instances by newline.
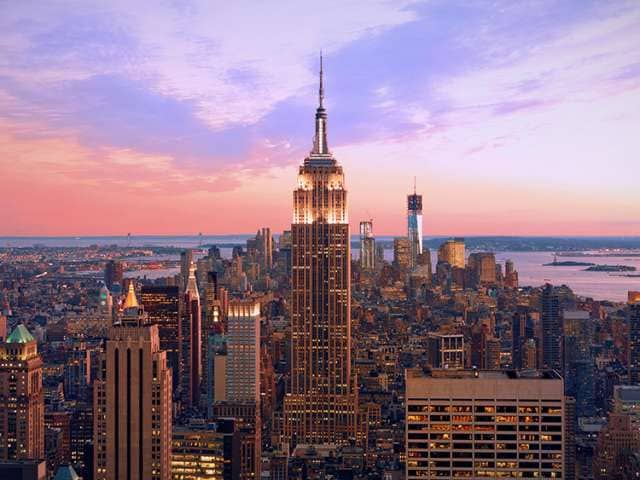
93, 323, 172, 480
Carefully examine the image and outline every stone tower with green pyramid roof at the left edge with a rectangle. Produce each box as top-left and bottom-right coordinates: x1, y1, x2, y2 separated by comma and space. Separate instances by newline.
0, 324, 45, 461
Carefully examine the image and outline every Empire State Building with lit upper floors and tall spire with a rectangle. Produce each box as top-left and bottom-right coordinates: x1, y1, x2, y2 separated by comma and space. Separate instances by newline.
284, 57, 357, 444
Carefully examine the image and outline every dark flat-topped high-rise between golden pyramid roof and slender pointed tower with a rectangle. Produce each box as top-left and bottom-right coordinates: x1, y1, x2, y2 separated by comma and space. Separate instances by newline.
140, 285, 180, 391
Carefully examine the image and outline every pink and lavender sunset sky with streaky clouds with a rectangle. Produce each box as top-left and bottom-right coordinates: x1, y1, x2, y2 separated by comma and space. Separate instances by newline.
0, 0, 640, 236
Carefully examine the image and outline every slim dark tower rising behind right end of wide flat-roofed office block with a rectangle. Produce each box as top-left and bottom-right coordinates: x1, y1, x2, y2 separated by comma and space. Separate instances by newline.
541, 284, 562, 372
